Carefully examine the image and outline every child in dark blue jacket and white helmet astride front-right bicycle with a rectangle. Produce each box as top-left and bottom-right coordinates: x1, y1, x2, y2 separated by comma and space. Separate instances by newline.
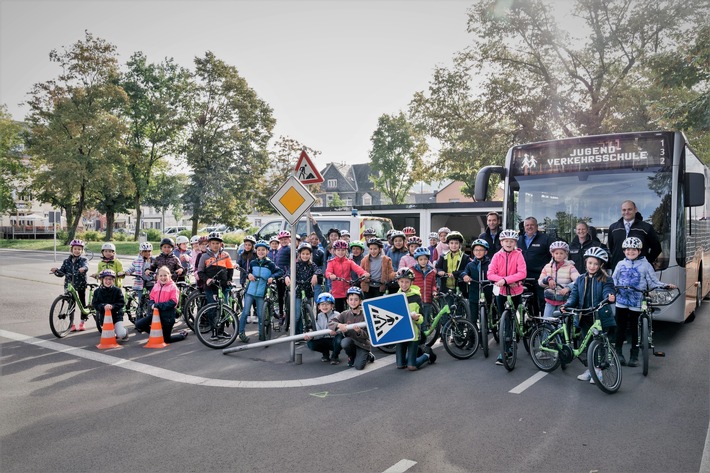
561, 246, 616, 384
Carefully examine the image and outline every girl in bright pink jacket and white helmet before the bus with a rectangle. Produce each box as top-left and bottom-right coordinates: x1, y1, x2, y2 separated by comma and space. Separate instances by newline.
488, 229, 528, 365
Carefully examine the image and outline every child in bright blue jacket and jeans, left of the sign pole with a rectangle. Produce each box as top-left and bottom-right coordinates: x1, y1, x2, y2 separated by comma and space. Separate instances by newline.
239, 240, 284, 343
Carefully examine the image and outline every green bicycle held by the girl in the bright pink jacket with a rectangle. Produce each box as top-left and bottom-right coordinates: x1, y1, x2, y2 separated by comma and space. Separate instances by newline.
499, 278, 535, 371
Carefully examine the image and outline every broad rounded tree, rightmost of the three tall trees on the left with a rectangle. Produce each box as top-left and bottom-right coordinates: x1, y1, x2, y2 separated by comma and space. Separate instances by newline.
184, 51, 275, 233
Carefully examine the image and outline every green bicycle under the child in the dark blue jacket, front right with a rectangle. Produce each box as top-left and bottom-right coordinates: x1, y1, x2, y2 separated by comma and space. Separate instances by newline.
530, 299, 621, 394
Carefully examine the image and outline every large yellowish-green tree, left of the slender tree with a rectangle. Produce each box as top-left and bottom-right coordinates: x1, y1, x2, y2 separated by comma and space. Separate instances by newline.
27, 31, 126, 242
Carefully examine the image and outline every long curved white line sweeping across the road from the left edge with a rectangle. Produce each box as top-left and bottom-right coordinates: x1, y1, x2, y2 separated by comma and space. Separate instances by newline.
0, 330, 394, 388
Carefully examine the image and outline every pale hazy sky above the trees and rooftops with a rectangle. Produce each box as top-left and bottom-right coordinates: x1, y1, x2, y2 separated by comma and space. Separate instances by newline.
0, 0, 482, 169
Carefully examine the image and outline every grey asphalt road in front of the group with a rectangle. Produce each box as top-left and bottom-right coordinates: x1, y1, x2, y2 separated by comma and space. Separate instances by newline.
0, 250, 710, 473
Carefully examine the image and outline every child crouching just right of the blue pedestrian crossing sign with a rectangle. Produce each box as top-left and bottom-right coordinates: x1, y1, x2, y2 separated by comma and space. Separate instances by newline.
395, 268, 436, 371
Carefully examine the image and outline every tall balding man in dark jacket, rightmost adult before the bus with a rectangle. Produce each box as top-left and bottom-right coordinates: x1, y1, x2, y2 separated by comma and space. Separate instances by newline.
607, 200, 661, 271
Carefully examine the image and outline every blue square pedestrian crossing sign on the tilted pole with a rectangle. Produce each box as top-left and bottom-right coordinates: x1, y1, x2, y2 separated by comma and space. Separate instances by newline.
362, 292, 416, 347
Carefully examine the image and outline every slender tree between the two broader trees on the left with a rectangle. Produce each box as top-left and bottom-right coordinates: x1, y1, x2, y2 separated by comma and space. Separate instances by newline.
121, 52, 192, 239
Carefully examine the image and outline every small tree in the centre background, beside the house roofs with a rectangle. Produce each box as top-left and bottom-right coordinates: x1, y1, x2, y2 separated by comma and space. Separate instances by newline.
370, 112, 429, 205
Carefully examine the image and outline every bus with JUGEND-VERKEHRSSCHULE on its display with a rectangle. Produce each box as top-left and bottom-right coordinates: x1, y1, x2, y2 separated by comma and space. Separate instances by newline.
475, 131, 710, 322
